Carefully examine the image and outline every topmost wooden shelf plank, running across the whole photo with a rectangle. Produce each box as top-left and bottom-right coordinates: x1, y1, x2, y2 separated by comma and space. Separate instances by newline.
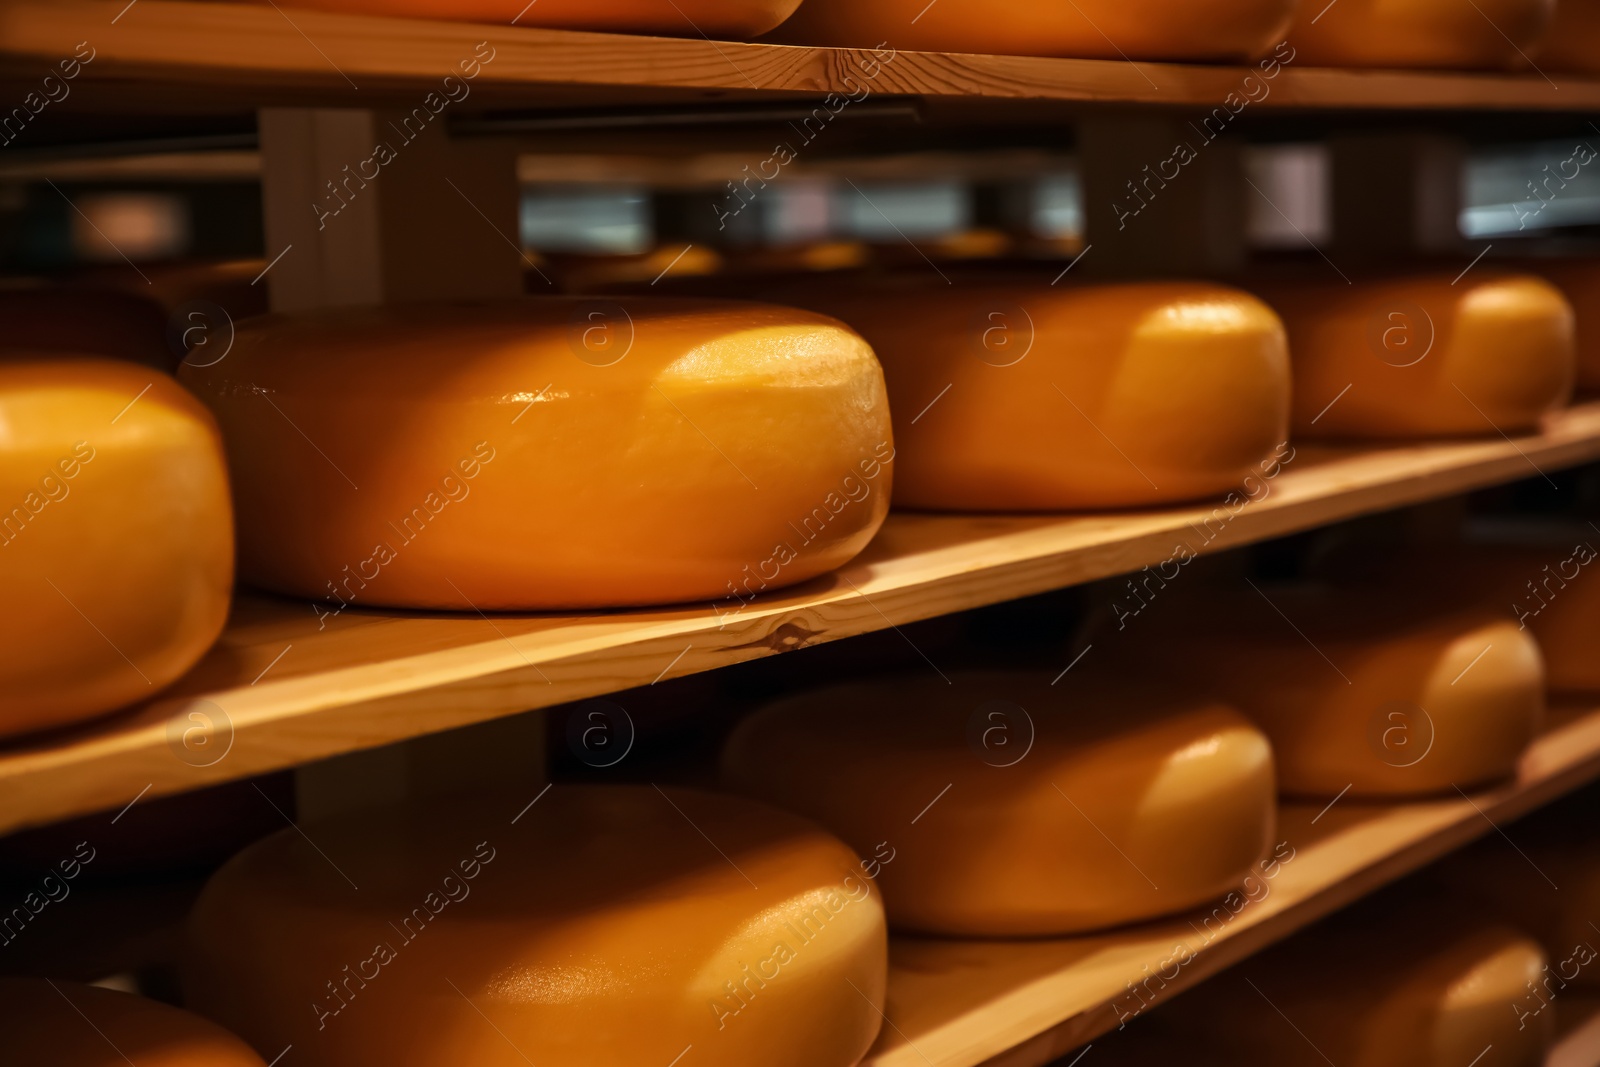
0, 0, 1600, 112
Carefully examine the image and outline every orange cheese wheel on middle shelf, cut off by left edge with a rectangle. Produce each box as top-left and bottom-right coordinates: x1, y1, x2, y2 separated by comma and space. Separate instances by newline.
0, 360, 234, 736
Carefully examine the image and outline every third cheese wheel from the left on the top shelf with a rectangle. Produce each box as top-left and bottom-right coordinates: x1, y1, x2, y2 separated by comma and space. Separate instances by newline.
1290, 0, 1571, 69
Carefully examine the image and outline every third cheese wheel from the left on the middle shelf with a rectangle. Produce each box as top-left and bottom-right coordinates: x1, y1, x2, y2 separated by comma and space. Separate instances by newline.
768, 277, 1290, 510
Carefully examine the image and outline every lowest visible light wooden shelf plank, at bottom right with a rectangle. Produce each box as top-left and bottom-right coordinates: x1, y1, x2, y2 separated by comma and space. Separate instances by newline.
862, 705, 1600, 1067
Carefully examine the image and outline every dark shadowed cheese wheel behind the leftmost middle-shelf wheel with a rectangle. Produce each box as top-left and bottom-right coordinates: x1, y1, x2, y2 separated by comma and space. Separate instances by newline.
0, 286, 178, 371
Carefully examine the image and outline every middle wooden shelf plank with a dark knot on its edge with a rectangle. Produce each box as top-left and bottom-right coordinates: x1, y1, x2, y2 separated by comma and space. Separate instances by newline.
0, 402, 1600, 832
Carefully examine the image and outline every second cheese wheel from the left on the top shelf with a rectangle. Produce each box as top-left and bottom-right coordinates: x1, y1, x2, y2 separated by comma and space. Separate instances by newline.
773, 0, 1294, 61
